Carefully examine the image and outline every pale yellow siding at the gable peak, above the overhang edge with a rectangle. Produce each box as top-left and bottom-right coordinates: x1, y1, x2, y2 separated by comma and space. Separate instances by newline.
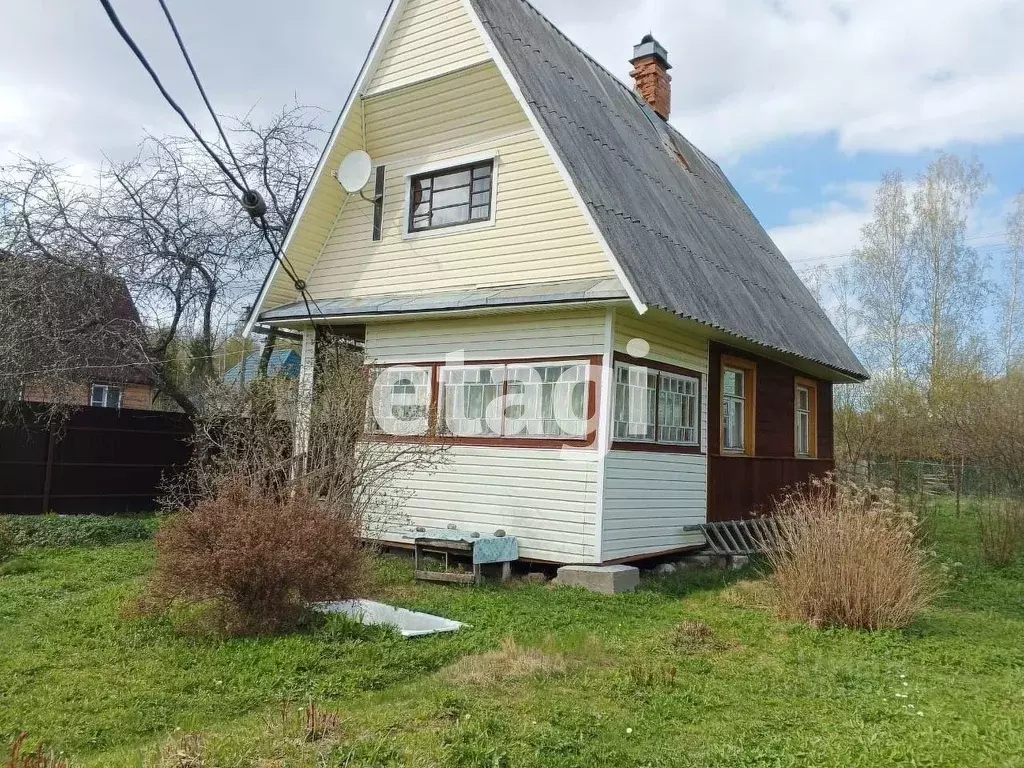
366, 0, 490, 95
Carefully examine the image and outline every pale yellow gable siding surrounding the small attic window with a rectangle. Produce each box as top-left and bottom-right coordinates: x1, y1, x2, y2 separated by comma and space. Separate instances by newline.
299, 66, 613, 298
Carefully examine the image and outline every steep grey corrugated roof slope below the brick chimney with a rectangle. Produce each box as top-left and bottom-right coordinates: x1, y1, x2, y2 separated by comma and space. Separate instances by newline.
471, 0, 867, 379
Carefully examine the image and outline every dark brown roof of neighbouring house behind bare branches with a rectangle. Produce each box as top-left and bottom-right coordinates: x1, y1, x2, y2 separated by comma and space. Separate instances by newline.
0, 259, 153, 384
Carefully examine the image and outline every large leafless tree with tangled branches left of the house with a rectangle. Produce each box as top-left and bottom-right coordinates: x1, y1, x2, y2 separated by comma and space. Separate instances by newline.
0, 106, 323, 416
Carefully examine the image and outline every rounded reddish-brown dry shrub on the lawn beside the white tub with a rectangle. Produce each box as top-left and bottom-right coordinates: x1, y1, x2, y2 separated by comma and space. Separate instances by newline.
144, 480, 370, 635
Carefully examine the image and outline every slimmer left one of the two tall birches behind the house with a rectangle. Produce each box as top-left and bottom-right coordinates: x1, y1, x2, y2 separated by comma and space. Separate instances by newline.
851, 171, 918, 379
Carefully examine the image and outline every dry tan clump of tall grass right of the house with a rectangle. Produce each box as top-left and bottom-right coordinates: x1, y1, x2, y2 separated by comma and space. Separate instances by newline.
768, 479, 938, 630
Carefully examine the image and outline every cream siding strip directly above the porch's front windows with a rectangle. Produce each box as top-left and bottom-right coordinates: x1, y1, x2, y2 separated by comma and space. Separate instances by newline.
366, 310, 604, 364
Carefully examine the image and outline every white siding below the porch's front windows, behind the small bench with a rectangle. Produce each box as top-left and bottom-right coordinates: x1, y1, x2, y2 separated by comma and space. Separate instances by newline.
374, 445, 597, 562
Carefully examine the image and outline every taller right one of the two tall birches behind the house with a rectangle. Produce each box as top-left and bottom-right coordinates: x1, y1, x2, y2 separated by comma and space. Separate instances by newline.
911, 153, 988, 398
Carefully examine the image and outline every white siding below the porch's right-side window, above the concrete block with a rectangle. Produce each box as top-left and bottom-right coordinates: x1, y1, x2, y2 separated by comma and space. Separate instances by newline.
601, 451, 708, 560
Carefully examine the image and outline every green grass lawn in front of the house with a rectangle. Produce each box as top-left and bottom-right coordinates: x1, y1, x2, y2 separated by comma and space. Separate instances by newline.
0, 517, 1024, 768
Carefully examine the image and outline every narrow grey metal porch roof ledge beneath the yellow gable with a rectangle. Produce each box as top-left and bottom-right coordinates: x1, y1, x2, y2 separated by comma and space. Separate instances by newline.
260, 278, 629, 323
